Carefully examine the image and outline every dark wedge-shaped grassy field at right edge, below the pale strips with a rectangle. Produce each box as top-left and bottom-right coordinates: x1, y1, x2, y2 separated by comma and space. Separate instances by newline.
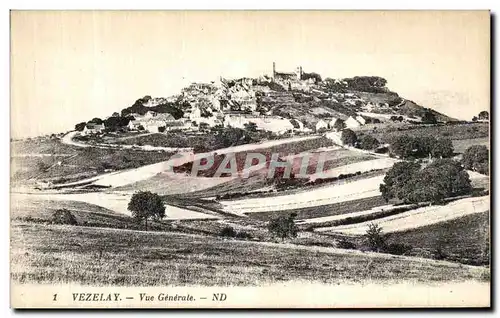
388, 212, 490, 265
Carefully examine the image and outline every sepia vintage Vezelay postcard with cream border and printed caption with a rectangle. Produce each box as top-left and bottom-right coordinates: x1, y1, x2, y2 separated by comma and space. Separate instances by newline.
10, 11, 491, 308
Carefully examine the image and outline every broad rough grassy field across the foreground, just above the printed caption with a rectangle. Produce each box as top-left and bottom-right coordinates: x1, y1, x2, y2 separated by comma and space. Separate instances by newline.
11, 222, 490, 286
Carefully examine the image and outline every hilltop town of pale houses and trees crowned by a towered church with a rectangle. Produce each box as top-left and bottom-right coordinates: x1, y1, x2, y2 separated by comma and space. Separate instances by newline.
75, 63, 453, 139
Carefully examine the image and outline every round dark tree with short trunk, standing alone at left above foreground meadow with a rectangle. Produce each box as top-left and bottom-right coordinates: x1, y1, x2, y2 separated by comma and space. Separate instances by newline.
128, 191, 165, 231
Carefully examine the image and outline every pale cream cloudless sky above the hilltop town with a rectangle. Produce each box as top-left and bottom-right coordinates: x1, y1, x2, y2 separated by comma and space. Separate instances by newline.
11, 11, 490, 138
